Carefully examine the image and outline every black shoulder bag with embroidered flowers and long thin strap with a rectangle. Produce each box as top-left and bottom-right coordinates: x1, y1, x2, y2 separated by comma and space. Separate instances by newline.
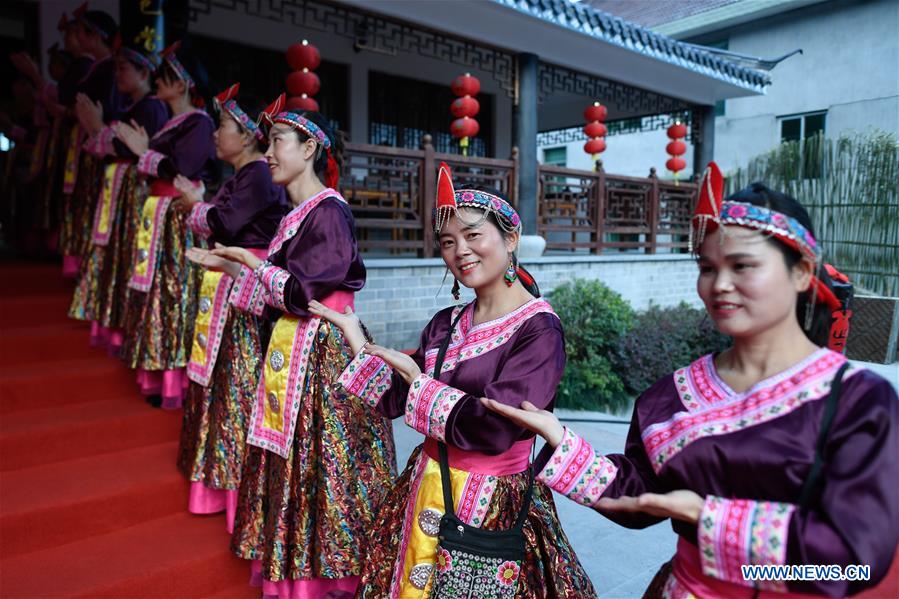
431, 310, 534, 599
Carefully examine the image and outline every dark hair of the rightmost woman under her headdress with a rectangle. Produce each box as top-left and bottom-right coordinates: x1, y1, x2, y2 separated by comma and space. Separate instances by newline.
725, 182, 834, 347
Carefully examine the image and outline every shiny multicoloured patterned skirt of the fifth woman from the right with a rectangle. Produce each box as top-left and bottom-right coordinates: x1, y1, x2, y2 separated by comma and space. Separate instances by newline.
122, 203, 203, 371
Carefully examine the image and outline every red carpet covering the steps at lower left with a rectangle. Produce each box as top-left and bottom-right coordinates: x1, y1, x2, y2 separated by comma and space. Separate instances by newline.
0, 263, 253, 599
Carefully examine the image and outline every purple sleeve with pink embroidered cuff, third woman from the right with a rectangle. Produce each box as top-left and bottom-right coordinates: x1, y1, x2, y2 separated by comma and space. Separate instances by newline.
260, 199, 365, 317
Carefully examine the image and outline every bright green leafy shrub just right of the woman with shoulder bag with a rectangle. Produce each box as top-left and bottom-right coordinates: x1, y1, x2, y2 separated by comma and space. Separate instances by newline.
548, 279, 634, 412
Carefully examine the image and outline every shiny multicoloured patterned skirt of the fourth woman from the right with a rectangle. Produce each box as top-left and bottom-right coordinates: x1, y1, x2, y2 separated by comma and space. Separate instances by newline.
178, 309, 263, 490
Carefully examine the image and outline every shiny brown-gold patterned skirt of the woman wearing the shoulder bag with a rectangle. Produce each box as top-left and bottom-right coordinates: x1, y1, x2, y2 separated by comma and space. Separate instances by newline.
356, 446, 596, 599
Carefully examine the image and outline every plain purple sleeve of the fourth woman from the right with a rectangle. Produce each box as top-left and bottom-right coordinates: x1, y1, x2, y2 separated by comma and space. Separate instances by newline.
206, 163, 280, 245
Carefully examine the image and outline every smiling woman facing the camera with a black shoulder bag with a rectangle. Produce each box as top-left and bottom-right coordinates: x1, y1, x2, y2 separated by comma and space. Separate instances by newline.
309, 165, 596, 599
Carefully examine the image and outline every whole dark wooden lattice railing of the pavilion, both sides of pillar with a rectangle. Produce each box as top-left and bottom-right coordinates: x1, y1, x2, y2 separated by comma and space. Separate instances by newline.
340, 145, 696, 257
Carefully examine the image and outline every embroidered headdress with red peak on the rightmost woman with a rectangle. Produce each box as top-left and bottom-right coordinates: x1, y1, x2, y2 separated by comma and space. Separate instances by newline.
690, 162, 852, 351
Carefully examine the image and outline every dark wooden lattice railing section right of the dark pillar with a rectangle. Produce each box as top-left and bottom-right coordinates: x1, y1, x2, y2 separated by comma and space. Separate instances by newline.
537, 162, 696, 254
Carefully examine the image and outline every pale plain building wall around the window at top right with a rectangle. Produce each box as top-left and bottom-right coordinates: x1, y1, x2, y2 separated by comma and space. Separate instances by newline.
715, 0, 899, 170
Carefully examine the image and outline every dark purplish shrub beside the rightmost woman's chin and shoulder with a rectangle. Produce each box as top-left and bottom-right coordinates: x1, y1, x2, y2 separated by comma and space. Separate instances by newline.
612, 302, 730, 395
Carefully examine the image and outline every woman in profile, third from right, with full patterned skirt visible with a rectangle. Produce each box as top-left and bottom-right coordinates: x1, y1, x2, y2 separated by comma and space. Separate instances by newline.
190, 101, 396, 597
